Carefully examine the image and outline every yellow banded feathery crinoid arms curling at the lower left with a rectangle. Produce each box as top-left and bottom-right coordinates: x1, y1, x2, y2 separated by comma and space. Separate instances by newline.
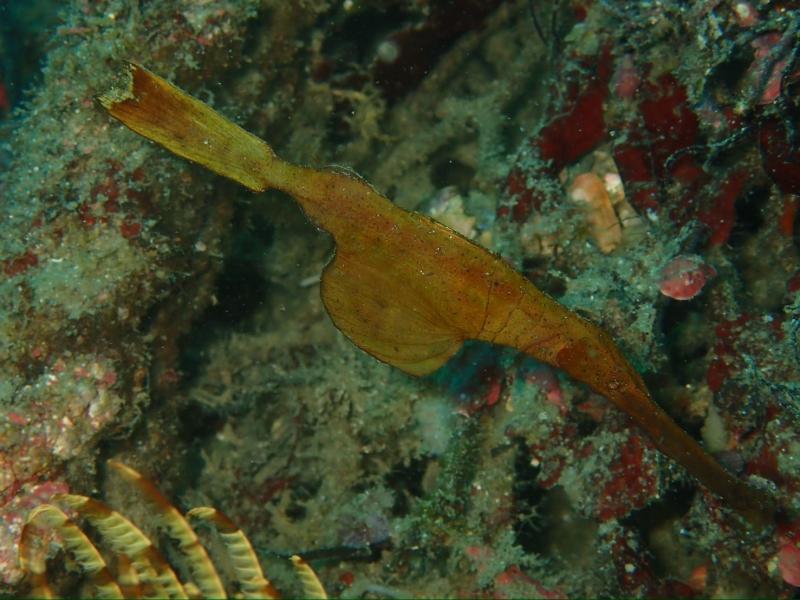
19, 460, 327, 598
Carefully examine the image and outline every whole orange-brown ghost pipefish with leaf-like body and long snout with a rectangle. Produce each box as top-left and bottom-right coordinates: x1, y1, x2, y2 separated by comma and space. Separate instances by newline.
99, 64, 773, 522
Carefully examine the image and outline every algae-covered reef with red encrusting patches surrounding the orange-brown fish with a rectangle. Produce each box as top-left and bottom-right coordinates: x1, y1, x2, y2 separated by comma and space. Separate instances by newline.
0, 0, 800, 598
